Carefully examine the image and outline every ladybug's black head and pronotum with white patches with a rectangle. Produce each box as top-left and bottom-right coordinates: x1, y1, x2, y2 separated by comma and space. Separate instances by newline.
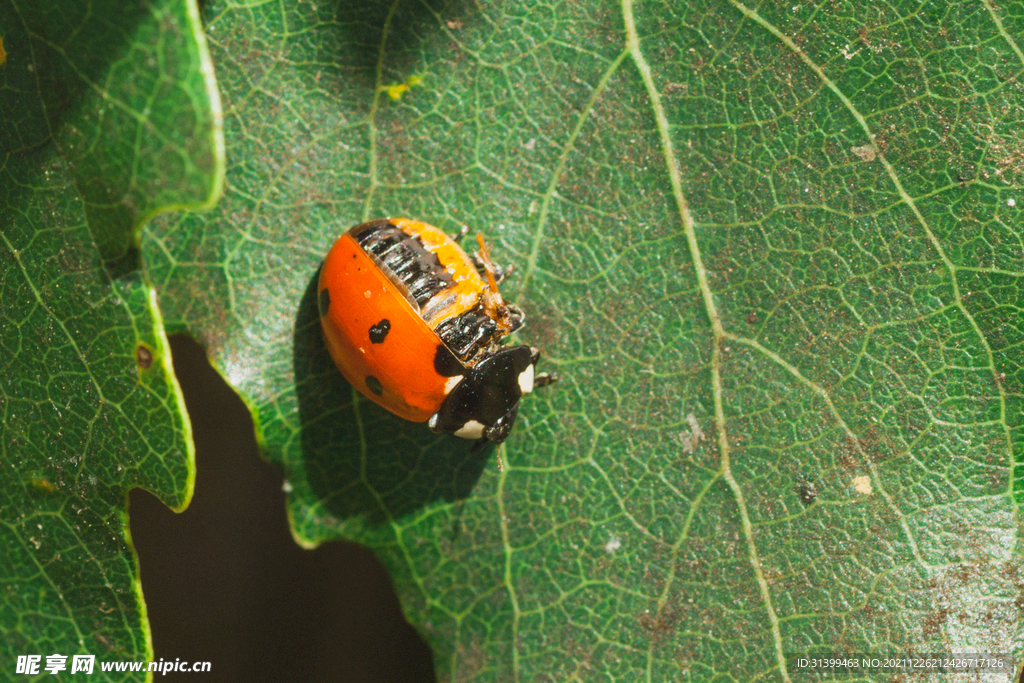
428, 346, 541, 443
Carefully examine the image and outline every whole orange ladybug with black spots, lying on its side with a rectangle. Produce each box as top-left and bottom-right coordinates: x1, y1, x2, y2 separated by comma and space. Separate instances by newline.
317, 218, 557, 445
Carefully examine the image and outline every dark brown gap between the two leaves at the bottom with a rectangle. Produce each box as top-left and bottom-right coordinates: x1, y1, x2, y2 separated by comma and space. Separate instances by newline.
130, 337, 435, 683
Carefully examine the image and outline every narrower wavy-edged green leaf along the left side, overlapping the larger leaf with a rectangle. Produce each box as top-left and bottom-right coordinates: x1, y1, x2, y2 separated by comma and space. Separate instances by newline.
0, 0, 223, 680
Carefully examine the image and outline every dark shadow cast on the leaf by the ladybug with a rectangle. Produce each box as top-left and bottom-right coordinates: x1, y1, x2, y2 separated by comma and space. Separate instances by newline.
294, 271, 494, 524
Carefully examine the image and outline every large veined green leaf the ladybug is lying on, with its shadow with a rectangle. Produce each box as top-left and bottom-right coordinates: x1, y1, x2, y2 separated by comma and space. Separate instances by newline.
143, 0, 1024, 681
